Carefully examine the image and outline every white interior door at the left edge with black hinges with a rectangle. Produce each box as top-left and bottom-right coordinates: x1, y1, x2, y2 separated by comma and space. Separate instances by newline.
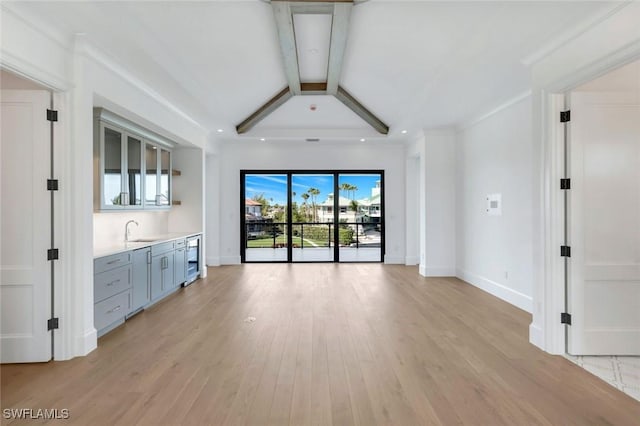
0, 90, 51, 363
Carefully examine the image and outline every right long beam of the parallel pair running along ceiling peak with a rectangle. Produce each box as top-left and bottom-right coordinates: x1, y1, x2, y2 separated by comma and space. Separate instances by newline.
327, 3, 353, 95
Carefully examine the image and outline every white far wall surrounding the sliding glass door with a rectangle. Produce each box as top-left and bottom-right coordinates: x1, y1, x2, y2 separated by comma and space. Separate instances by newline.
214, 142, 405, 264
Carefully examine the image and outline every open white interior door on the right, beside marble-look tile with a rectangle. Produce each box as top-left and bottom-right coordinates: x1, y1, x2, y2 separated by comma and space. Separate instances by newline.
568, 92, 640, 355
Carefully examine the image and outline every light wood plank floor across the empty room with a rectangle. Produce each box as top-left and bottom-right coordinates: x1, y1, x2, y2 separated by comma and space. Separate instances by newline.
2, 264, 640, 425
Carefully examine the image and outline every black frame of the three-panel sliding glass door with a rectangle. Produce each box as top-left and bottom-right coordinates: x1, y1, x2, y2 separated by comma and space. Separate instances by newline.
240, 169, 386, 263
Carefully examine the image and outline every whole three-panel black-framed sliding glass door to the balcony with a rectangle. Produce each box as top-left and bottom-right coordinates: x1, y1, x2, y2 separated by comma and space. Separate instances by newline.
240, 170, 384, 262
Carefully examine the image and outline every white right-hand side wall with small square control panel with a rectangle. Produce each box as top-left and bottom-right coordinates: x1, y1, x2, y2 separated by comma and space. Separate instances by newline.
456, 96, 533, 312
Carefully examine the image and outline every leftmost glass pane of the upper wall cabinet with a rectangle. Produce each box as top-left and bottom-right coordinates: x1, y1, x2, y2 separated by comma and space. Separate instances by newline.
102, 127, 125, 206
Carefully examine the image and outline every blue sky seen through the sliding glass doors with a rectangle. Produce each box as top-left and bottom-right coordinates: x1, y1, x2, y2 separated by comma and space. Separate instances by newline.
245, 174, 380, 205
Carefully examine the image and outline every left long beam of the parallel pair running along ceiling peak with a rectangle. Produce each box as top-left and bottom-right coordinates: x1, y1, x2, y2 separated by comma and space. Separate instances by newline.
271, 1, 301, 95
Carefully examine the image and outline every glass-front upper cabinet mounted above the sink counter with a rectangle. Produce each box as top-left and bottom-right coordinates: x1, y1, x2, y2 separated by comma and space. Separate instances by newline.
94, 108, 173, 210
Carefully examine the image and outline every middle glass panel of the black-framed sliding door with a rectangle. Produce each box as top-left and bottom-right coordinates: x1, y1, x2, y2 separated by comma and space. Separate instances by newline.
291, 174, 335, 262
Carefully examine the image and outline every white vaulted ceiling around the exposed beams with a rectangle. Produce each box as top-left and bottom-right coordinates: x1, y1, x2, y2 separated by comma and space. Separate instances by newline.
7, 0, 611, 140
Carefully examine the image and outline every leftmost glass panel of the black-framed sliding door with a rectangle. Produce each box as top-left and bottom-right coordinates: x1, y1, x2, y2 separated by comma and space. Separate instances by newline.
243, 174, 289, 262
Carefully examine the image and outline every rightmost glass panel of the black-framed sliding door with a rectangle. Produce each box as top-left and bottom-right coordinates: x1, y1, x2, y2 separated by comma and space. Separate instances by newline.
338, 173, 384, 262
